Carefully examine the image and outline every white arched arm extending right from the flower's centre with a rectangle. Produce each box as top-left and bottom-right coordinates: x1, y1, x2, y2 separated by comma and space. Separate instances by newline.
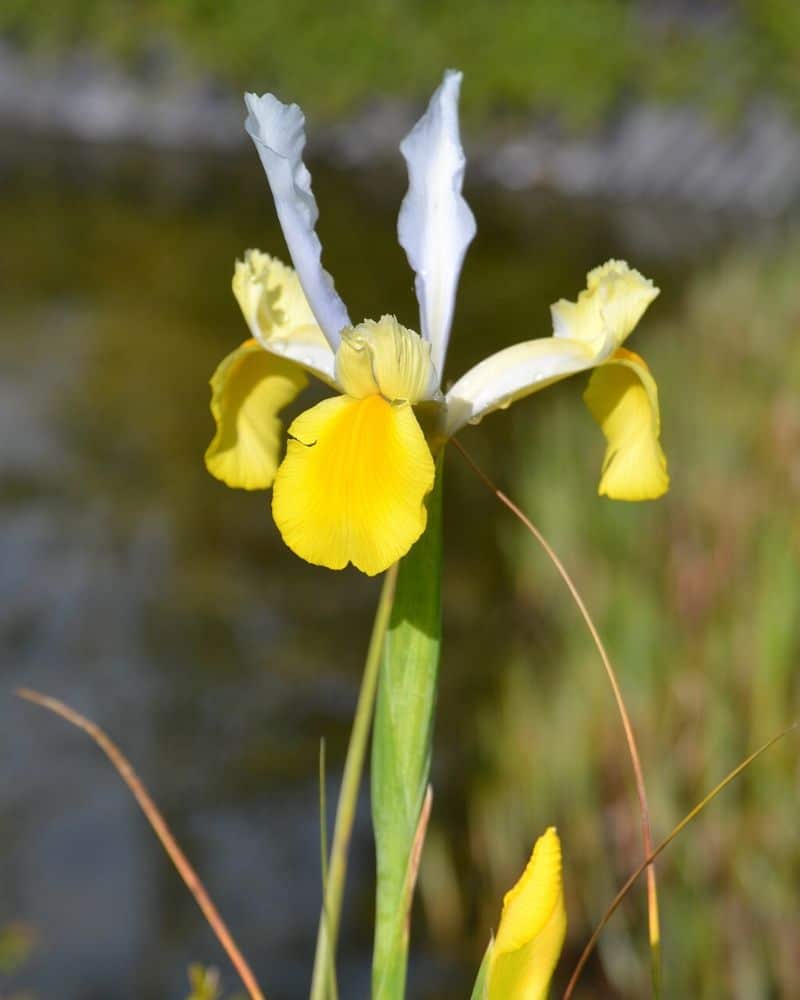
445, 337, 598, 437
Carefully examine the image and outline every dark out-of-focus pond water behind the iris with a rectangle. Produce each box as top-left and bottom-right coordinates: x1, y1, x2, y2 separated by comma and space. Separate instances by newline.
0, 137, 744, 1000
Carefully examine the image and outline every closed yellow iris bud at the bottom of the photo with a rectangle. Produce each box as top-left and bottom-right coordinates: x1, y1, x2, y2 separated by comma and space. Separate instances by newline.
487, 827, 567, 1000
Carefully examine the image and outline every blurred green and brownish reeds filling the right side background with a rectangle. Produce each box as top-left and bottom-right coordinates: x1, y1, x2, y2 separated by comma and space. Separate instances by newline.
454, 236, 800, 1000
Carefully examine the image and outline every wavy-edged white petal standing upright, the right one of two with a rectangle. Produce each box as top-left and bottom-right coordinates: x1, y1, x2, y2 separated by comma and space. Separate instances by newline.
397, 70, 475, 382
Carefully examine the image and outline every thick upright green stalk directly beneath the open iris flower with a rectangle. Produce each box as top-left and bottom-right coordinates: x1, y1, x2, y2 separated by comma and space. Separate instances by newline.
371, 454, 442, 1000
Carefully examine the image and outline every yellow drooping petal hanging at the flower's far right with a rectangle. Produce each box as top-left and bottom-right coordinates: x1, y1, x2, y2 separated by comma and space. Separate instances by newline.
583, 348, 669, 500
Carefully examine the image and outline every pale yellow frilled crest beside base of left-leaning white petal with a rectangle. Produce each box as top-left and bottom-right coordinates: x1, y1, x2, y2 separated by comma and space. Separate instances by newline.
232, 250, 326, 343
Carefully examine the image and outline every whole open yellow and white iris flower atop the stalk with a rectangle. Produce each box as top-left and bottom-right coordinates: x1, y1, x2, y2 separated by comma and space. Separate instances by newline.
206, 71, 668, 575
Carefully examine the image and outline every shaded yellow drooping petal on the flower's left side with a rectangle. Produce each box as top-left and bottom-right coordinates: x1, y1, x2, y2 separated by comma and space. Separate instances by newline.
206, 340, 308, 490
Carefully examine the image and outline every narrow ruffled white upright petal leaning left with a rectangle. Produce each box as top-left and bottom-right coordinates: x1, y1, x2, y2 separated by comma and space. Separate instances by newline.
244, 94, 352, 351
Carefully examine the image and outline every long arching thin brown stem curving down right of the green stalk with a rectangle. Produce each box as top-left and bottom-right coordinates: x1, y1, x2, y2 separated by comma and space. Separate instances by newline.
450, 438, 661, 997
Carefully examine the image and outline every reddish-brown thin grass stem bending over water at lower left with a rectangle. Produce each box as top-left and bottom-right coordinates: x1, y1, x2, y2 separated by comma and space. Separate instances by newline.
17, 688, 265, 1000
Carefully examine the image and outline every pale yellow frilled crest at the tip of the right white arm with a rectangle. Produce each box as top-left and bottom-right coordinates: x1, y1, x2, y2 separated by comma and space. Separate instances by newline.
550, 260, 659, 353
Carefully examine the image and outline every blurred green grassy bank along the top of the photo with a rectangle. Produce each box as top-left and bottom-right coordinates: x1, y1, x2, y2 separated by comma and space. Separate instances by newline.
0, 0, 800, 128
